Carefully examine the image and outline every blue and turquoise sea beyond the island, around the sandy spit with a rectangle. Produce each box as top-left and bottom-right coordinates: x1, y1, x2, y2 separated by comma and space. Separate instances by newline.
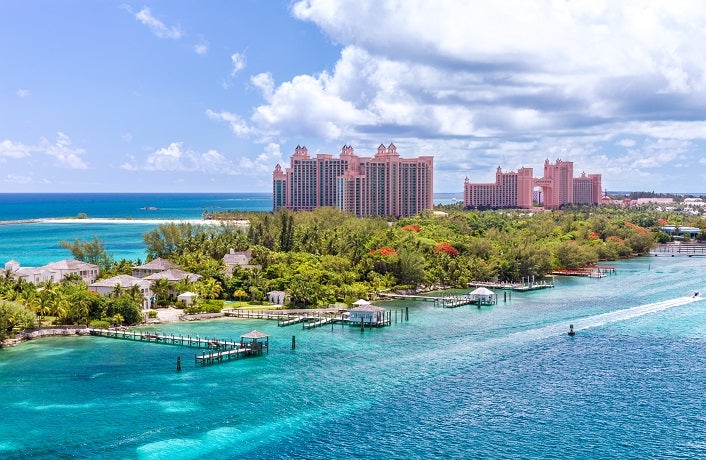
0, 193, 272, 267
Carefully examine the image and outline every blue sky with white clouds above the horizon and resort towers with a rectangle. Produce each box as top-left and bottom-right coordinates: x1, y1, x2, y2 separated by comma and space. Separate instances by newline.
0, 0, 706, 193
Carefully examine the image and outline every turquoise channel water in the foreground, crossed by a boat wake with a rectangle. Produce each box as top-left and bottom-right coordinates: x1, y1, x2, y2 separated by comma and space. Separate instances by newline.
0, 257, 706, 459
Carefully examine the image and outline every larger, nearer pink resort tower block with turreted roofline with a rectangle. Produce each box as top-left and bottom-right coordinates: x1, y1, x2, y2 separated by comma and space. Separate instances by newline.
272, 144, 434, 217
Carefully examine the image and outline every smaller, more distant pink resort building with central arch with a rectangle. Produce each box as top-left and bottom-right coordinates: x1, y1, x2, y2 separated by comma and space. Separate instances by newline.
463, 160, 602, 209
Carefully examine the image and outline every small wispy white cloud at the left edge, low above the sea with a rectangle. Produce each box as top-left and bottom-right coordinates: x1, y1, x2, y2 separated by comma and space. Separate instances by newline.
0, 132, 88, 169
